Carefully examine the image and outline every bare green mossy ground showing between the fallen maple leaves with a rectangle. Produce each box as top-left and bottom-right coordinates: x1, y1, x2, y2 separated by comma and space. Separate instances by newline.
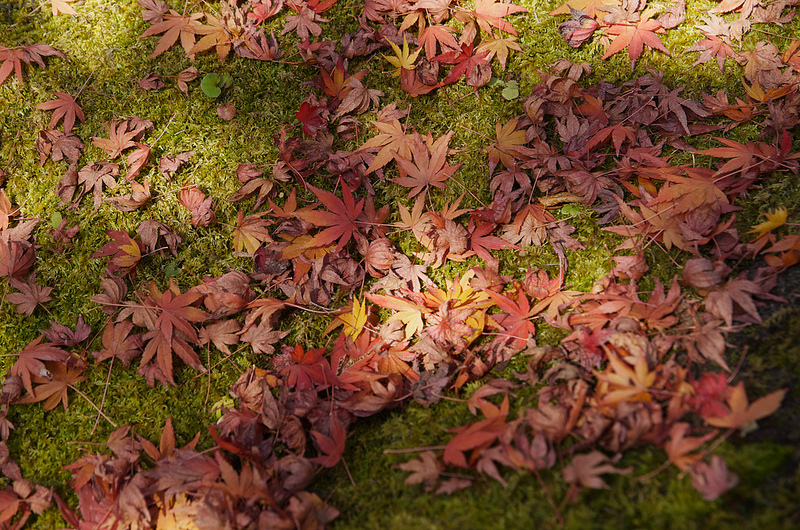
0, 0, 800, 530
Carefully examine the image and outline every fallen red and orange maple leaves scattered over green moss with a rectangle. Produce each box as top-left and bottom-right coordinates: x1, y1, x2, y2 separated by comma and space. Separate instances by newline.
0, 0, 800, 528
